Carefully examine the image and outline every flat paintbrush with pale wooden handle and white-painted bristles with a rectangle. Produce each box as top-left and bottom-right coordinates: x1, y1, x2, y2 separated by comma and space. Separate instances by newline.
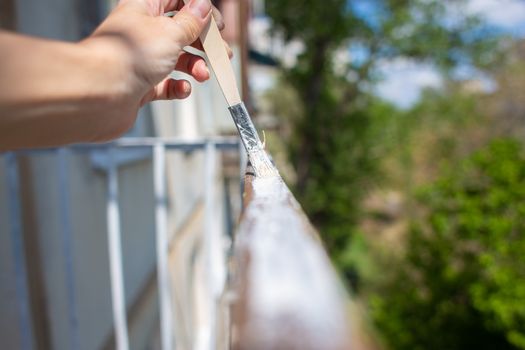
180, 5, 279, 177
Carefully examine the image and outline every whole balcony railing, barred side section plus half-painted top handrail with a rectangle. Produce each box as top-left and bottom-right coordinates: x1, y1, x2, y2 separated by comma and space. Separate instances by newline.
4, 138, 351, 350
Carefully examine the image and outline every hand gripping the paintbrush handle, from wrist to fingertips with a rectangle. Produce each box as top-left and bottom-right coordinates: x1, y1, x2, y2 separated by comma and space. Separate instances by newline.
84, 0, 231, 106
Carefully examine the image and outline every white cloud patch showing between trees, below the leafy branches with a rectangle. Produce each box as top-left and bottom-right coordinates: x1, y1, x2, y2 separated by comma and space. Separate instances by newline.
376, 59, 442, 108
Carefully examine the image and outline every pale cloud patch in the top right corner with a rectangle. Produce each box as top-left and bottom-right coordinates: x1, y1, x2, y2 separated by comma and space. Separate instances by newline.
467, 0, 525, 29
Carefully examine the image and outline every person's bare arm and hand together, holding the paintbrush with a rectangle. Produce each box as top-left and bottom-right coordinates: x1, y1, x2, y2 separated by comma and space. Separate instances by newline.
0, 0, 229, 151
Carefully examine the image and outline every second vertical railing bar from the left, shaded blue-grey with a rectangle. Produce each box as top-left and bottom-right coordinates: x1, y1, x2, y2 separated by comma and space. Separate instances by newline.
57, 148, 80, 349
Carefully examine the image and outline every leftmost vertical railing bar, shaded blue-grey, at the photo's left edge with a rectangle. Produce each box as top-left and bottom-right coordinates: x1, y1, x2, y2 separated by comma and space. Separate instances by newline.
5, 153, 34, 350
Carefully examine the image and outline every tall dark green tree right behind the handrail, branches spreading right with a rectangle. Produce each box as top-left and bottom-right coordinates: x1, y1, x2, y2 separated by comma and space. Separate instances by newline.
266, 0, 504, 278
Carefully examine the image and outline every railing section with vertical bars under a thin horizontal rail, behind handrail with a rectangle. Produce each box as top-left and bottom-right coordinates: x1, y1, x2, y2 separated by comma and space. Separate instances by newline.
3, 138, 242, 350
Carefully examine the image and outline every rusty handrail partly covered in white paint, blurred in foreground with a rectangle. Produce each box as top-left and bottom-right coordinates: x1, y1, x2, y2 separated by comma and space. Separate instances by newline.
232, 168, 353, 350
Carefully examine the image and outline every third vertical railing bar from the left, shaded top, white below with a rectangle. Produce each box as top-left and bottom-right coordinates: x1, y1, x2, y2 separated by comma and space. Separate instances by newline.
107, 148, 129, 350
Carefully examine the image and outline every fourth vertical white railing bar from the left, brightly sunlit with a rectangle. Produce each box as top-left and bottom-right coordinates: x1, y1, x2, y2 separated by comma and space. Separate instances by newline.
153, 142, 173, 350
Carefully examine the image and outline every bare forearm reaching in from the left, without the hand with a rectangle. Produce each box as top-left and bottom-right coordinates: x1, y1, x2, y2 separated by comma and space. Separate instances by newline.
0, 32, 139, 150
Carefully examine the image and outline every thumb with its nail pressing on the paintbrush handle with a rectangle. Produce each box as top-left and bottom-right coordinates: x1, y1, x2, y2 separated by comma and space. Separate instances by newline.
172, 0, 212, 48
